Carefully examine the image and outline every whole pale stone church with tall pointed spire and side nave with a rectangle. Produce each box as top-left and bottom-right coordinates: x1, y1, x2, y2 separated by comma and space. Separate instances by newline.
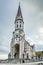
8, 4, 35, 62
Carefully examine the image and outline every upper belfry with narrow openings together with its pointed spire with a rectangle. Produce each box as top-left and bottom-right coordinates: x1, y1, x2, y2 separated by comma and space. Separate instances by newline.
15, 4, 24, 31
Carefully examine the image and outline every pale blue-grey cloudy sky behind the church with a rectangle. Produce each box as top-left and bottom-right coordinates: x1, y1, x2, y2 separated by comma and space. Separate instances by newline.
0, 0, 43, 59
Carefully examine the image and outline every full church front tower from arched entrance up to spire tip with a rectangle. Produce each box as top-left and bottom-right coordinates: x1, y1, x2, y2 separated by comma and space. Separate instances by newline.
11, 4, 25, 58
